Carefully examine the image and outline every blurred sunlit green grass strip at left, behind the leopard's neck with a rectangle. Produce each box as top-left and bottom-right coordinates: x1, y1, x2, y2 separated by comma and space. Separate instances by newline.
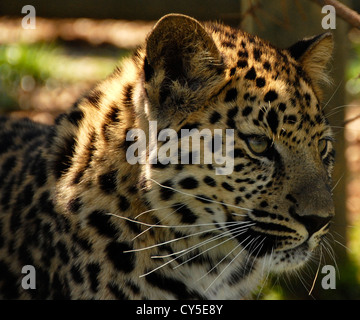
0, 44, 128, 111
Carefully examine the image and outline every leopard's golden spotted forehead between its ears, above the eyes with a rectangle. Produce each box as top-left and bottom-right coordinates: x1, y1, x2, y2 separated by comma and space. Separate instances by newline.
200, 24, 330, 136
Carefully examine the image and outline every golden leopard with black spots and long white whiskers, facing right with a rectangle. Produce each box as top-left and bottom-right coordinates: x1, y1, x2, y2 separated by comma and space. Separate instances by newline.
0, 13, 335, 300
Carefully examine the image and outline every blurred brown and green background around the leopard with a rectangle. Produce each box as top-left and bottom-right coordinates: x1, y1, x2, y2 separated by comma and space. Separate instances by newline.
0, 0, 360, 299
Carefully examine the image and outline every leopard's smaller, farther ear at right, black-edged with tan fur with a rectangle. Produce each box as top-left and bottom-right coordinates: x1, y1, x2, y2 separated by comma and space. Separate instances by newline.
288, 32, 334, 84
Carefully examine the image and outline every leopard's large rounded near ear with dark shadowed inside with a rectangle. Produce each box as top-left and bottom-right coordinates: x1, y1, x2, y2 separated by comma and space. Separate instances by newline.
144, 14, 224, 114
